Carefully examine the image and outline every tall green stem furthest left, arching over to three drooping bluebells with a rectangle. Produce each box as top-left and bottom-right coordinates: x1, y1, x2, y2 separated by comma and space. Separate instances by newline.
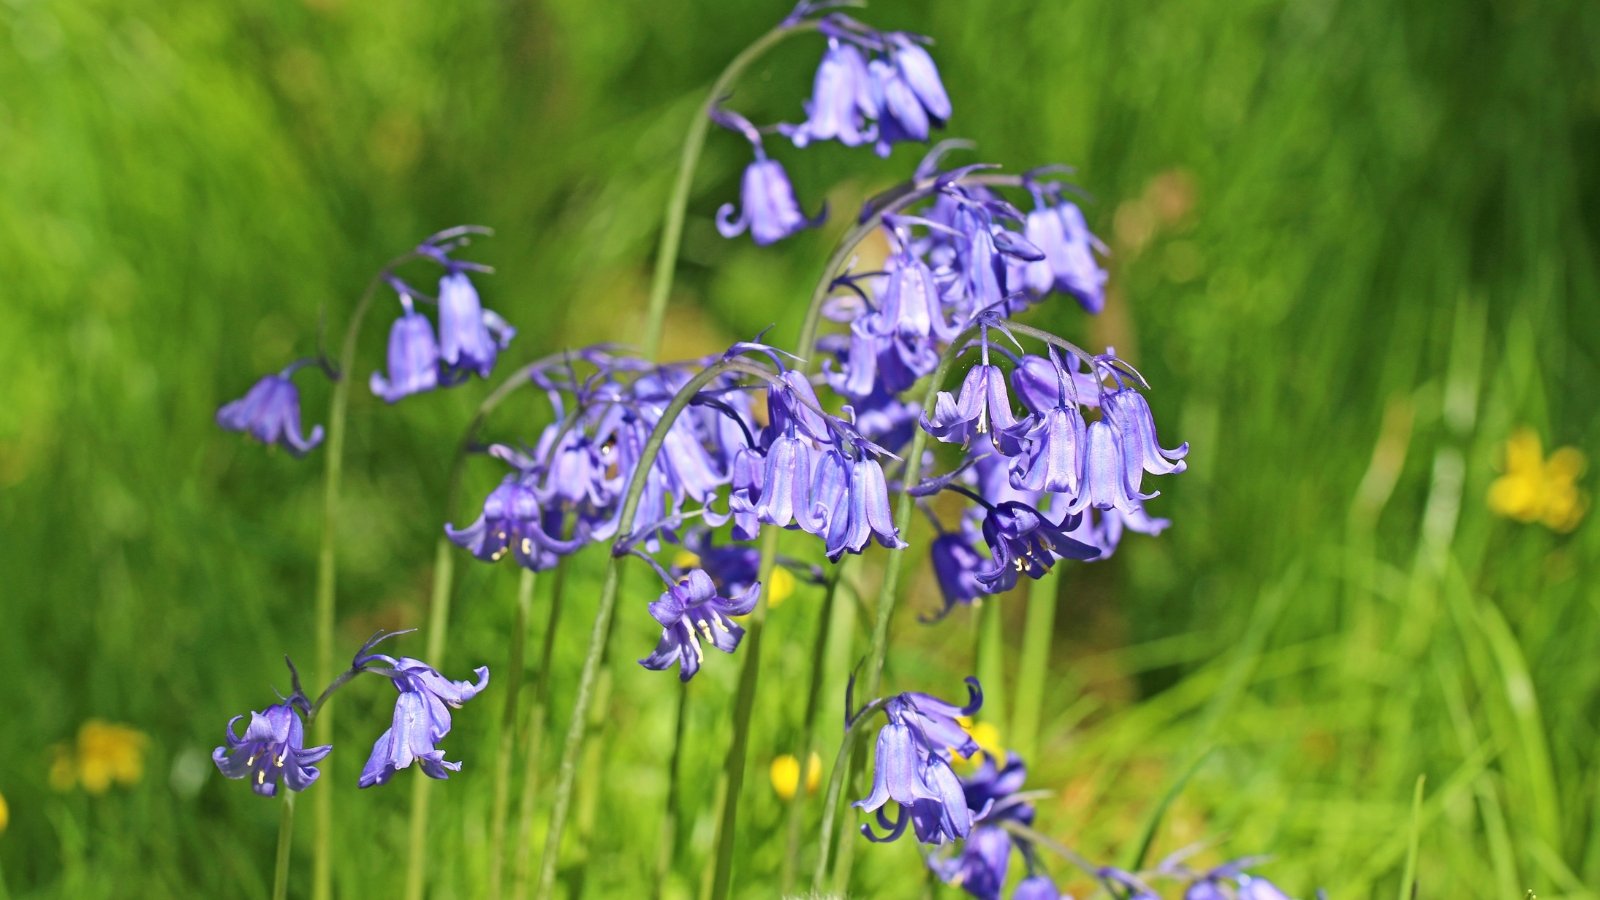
312, 251, 398, 900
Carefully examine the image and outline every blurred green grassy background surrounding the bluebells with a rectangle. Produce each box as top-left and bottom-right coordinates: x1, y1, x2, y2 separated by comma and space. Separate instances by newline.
0, 0, 1600, 900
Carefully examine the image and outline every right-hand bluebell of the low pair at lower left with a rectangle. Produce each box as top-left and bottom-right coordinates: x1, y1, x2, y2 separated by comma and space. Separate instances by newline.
355, 653, 490, 788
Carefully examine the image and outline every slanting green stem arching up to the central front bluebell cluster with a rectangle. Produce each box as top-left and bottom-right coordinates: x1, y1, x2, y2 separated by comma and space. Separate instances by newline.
534, 359, 766, 897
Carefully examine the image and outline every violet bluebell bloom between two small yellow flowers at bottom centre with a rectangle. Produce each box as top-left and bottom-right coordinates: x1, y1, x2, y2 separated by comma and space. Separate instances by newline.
851, 677, 984, 844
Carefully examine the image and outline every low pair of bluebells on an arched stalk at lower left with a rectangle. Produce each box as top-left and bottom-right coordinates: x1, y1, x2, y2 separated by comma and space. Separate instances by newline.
211, 633, 490, 798
